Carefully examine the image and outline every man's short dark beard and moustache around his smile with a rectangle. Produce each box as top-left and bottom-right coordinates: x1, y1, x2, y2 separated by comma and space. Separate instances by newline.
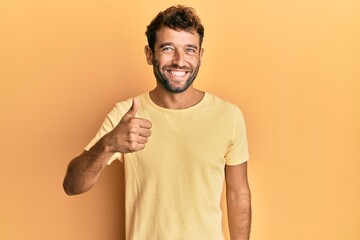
153, 60, 200, 93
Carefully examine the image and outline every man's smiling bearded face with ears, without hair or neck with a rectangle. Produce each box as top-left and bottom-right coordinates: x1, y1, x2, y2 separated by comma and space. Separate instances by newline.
145, 27, 203, 93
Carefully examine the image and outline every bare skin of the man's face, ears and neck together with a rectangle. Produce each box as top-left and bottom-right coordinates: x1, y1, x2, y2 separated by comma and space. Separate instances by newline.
145, 27, 204, 109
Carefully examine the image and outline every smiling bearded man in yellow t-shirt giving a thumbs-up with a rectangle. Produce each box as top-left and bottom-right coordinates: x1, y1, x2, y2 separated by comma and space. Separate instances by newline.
64, 6, 251, 240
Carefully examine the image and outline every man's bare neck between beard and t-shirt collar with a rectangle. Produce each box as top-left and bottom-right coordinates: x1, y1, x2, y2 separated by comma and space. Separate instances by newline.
150, 86, 205, 109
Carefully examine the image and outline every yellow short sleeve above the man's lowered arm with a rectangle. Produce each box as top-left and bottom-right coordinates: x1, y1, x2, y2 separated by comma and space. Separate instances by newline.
225, 107, 249, 165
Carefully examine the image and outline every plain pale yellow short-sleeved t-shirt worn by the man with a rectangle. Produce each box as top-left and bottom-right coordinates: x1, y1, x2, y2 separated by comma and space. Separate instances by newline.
85, 93, 248, 240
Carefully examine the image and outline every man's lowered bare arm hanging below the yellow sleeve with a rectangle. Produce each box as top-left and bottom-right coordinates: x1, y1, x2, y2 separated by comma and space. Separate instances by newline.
225, 162, 251, 240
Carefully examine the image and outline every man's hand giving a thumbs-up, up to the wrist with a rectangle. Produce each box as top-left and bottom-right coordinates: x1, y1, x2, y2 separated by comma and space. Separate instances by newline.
107, 98, 152, 153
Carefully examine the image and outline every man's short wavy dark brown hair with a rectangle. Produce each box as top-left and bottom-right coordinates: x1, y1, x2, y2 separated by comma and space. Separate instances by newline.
145, 5, 204, 52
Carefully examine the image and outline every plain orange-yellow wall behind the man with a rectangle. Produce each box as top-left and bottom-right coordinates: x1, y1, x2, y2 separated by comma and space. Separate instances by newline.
0, 0, 360, 240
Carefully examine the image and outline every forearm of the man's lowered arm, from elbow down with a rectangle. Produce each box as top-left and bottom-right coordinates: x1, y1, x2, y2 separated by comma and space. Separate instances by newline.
227, 188, 251, 240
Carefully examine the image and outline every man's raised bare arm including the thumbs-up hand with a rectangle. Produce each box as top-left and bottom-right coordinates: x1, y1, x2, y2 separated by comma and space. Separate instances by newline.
63, 98, 151, 195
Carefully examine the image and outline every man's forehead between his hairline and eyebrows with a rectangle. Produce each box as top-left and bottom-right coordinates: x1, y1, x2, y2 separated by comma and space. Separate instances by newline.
155, 27, 200, 47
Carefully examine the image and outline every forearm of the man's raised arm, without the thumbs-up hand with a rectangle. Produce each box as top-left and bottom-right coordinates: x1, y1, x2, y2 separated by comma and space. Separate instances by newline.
63, 136, 113, 195
